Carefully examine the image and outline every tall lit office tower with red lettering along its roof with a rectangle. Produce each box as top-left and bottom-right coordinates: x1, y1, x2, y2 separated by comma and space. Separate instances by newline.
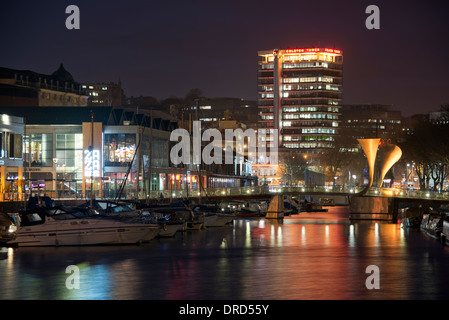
258, 48, 343, 153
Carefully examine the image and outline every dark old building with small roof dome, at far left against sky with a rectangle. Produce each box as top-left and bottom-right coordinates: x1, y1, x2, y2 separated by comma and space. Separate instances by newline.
0, 64, 88, 107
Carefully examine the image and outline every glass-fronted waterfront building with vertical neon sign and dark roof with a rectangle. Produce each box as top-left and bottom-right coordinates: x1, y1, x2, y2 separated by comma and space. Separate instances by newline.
0, 107, 177, 198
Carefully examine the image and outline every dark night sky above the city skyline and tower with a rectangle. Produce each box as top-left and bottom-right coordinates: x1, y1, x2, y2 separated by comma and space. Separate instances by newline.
0, 0, 449, 116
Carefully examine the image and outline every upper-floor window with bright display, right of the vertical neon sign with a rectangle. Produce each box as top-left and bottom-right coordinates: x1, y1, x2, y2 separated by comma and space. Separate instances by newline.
104, 133, 136, 166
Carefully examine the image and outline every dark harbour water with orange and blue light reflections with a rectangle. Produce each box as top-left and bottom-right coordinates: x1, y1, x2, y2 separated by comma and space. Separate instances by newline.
0, 207, 449, 300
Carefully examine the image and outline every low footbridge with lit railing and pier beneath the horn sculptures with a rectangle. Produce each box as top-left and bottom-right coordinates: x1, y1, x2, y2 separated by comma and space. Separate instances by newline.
0, 186, 449, 220
